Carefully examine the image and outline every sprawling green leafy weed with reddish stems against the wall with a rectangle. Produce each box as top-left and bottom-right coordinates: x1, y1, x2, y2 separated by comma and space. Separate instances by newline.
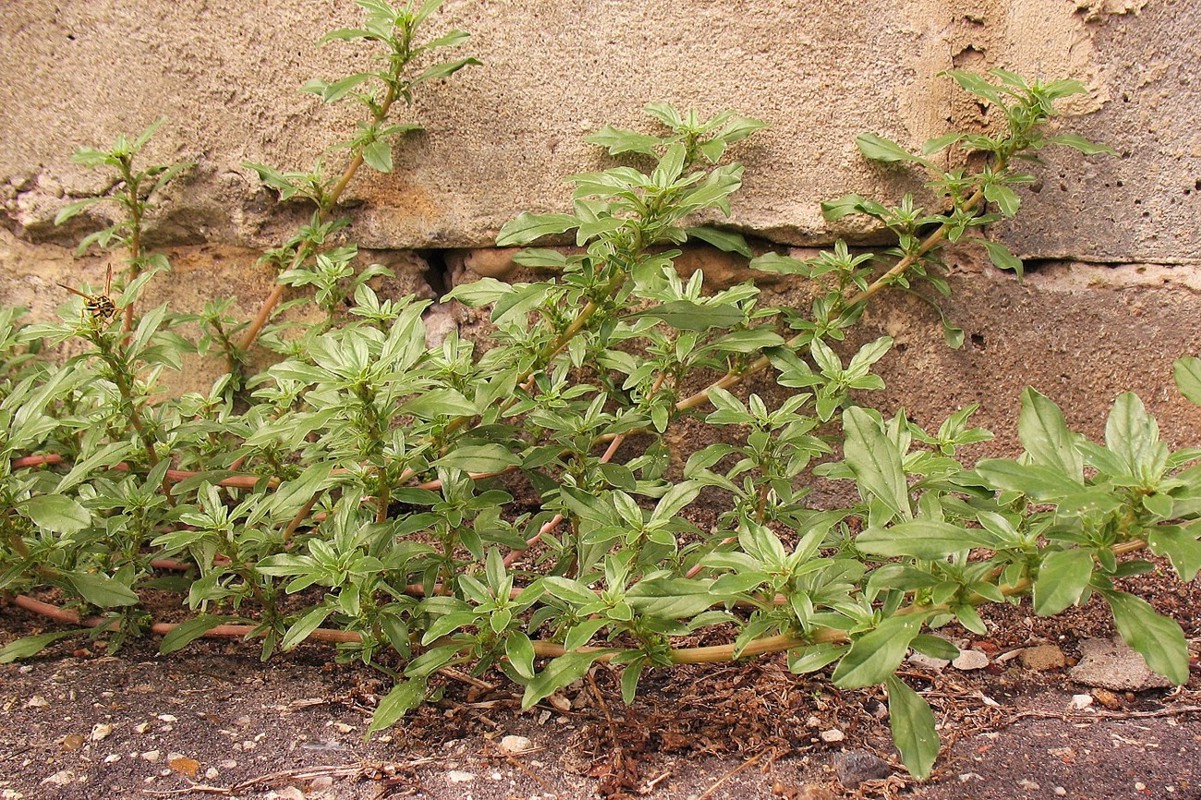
0, 35, 1201, 777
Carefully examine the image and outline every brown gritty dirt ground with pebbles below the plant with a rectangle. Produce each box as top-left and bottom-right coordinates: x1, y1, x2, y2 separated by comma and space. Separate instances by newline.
0, 564, 1201, 800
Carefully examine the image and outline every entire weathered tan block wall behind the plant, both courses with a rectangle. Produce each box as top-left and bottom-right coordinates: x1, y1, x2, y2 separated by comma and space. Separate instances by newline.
0, 0, 1201, 449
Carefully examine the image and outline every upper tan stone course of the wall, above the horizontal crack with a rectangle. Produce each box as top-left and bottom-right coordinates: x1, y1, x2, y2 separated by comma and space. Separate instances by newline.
0, 0, 1201, 257
